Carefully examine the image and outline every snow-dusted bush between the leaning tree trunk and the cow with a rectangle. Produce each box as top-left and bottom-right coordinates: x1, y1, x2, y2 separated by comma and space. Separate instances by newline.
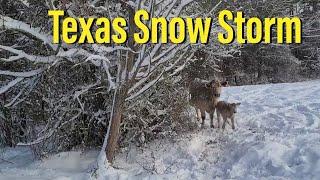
120, 78, 197, 146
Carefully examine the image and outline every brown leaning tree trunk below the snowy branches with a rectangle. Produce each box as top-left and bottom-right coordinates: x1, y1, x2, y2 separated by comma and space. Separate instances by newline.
105, 87, 127, 163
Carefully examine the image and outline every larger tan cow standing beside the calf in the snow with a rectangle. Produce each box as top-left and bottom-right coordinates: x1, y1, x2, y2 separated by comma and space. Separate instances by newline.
189, 80, 228, 128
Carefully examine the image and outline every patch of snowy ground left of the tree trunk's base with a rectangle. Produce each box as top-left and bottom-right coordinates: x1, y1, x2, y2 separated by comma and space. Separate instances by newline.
0, 147, 97, 180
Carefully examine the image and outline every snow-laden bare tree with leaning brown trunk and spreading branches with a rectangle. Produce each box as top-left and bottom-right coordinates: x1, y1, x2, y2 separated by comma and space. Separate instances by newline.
0, 0, 225, 165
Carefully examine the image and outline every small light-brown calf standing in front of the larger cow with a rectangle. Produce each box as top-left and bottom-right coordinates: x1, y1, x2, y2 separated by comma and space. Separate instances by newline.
216, 101, 241, 129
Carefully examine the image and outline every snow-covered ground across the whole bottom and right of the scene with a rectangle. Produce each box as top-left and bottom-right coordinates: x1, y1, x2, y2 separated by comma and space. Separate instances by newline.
0, 80, 320, 180
